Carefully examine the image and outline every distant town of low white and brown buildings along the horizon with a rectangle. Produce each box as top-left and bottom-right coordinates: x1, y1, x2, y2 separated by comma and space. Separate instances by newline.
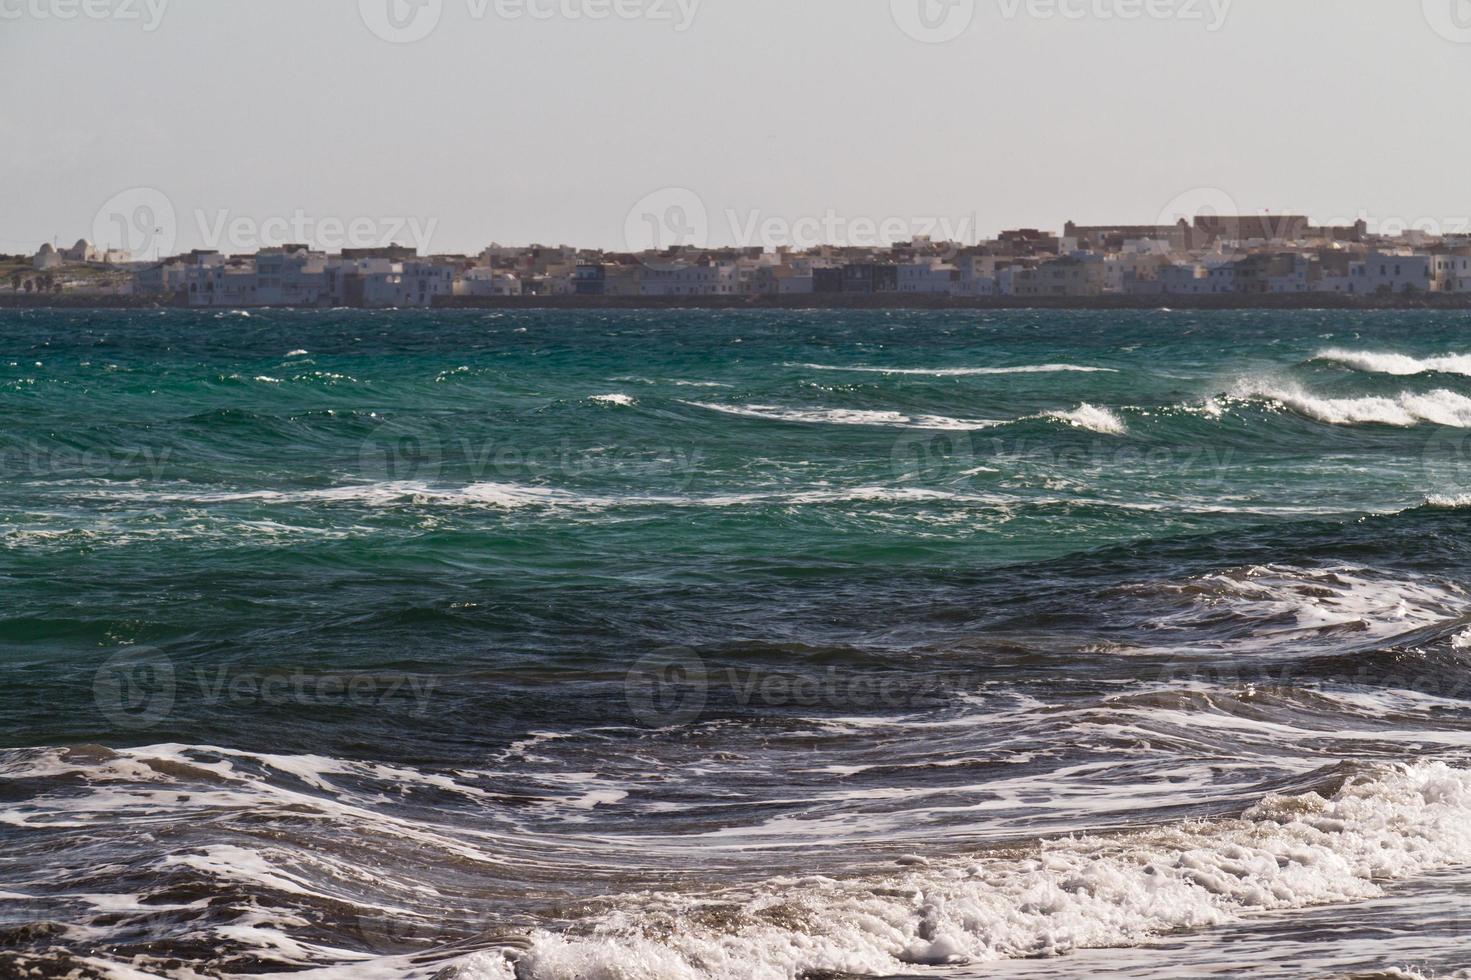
0, 215, 1471, 309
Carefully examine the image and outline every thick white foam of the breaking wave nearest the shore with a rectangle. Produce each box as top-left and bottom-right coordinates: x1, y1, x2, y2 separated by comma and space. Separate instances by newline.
459, 762, 1471, 980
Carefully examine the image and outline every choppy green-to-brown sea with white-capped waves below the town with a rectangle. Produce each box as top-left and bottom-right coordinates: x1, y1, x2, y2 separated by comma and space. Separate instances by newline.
0, 309, 1471, 980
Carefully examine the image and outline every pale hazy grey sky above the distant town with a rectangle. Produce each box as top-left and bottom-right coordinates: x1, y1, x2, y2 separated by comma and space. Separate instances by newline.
0, 0, 1471, 258
